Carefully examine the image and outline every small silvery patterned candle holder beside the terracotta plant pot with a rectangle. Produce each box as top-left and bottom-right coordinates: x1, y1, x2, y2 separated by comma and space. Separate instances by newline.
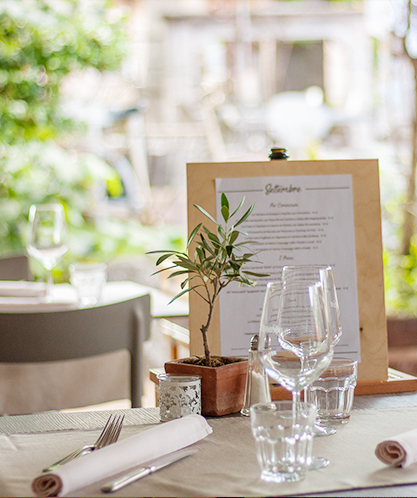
157, 373, 201, 422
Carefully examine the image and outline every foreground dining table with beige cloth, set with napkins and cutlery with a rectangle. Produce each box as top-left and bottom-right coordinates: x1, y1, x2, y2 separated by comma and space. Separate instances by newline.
0, 392, 417, 497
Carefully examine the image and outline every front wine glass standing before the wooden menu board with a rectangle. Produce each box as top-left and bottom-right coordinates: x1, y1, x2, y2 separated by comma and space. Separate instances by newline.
258, 281, 333, 469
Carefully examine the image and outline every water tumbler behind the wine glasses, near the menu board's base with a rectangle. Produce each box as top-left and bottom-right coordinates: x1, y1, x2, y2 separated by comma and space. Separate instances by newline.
306, 357, 358, 425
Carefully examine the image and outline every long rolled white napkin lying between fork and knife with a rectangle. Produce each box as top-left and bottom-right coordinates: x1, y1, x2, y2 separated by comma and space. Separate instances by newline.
32, 415, 213, 496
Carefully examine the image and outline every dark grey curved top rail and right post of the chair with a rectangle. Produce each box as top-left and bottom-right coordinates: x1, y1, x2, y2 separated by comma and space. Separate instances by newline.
0, 295, 151, 413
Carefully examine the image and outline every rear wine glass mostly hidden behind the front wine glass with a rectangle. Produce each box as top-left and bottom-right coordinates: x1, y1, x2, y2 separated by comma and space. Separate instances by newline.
282, 265, 342, 436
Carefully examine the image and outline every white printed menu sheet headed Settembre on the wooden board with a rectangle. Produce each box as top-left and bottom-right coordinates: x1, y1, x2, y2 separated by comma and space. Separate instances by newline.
216, 174, 360, 361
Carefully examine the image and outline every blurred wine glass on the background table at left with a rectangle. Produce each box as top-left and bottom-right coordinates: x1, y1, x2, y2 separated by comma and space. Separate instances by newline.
27, 204, 68, 302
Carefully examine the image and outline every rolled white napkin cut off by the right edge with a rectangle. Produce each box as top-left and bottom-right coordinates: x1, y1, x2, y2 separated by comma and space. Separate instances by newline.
375, 429, 417, 467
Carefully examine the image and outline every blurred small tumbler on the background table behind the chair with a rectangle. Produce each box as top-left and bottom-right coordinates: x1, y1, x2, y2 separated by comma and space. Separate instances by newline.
69, 263, 107, 306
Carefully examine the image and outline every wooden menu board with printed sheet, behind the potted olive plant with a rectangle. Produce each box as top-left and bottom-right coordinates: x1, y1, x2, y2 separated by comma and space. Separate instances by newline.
187, 159, 388, 381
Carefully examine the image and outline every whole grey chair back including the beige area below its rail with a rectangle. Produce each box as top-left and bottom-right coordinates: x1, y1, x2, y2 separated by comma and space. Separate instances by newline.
0, 295, 151, 414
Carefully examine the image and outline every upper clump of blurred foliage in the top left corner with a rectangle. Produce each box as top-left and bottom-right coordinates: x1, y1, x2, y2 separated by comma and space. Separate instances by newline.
0, 0, 127, 144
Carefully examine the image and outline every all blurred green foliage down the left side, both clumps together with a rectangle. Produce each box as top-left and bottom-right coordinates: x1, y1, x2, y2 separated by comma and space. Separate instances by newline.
0, 0, 183, 280
